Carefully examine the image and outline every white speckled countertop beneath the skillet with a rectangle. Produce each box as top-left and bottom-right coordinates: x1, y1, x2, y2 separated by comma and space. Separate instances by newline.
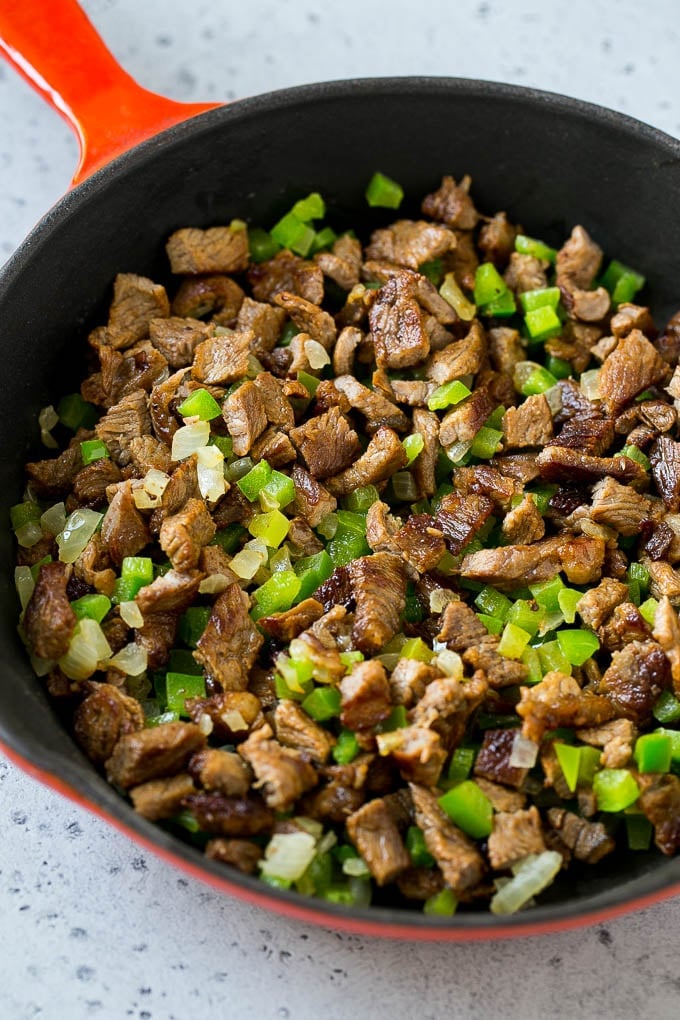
0, 0, 680, 1020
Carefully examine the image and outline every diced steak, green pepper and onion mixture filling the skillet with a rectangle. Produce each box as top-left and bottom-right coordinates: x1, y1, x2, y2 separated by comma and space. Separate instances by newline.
12, 173, 680, 915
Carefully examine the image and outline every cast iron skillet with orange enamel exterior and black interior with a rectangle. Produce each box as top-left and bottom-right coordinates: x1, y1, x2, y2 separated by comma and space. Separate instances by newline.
0, 0, 680, 940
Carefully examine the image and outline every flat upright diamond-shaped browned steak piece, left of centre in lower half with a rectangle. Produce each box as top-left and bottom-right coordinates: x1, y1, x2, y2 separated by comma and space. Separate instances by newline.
193, 587, 262, 691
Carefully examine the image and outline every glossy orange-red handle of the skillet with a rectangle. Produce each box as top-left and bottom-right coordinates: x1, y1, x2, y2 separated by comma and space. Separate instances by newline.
0, 0, 221, 185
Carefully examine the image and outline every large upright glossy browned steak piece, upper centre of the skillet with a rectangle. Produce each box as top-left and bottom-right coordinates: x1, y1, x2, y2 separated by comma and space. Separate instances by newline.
368, 272, 430, 368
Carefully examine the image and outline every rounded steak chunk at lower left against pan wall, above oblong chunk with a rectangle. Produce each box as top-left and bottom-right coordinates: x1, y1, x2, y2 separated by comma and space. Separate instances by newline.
73, 683, 144, 765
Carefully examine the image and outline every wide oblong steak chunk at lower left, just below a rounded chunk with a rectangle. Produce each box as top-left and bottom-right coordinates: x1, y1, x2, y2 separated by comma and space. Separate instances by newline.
105, 722, 206, 789
